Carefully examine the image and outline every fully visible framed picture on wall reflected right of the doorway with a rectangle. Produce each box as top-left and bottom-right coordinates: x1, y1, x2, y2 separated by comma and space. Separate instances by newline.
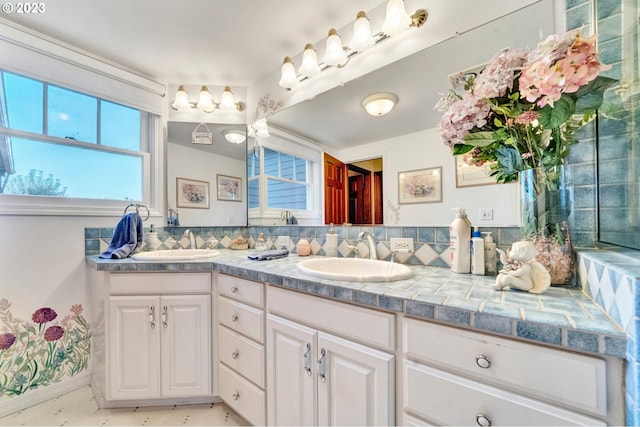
398, 166, 442, 205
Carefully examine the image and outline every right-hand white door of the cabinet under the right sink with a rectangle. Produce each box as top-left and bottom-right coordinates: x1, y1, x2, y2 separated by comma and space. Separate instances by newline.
317, 332, 395, 426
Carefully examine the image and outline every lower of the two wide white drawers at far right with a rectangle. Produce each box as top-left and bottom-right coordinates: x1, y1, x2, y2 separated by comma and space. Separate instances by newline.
403, 360, 606, 426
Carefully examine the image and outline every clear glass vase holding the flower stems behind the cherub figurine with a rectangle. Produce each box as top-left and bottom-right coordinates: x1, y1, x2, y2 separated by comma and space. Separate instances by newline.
519, 165, 575, 285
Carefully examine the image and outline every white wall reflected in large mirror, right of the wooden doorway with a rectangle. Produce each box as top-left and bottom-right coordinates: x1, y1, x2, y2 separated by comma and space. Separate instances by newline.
332, 129, 520, 227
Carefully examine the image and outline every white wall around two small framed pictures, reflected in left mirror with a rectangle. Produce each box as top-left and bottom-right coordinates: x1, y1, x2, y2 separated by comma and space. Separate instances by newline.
168, 143, 247, 226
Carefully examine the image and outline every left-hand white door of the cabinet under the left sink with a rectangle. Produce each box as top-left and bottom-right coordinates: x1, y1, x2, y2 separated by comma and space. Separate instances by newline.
106, 296, 161, 400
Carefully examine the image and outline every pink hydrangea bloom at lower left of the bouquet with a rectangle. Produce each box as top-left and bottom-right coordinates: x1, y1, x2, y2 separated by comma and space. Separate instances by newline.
439, 93, 491, 147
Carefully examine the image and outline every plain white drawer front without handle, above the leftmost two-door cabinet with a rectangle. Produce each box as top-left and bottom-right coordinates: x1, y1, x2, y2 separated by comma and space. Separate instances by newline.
108, 272, 211, 295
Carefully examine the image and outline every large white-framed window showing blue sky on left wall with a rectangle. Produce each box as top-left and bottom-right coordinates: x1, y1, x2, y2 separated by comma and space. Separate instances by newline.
0, 71, 153, 201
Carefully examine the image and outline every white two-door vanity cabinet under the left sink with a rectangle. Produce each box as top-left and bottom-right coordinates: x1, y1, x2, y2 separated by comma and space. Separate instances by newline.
96, 273, 212, 406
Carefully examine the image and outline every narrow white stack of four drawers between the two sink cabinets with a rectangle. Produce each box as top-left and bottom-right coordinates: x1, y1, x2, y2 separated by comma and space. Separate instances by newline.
216, 274, 266, 425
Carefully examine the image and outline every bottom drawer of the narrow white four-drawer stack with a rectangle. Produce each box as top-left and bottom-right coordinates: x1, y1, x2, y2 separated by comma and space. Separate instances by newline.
220, 364, 267, 426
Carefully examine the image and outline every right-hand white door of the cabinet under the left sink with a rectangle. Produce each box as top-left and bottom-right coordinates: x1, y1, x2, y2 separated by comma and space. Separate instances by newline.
160, 295, 211, 397
